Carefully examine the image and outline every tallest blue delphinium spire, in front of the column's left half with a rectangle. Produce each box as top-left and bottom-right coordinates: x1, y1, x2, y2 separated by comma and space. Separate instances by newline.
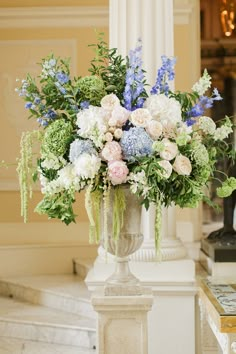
123, 40, 144, 111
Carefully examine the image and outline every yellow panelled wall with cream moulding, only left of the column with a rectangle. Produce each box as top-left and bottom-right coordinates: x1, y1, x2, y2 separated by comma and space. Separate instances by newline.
0, 0, 108, 262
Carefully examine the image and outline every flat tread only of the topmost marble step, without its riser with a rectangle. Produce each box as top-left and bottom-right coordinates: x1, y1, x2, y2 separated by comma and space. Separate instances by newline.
0, 274, 91, 302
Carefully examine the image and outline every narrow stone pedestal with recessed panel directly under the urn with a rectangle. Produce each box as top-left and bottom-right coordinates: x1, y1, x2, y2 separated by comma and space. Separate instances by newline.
92, 293, 153, 354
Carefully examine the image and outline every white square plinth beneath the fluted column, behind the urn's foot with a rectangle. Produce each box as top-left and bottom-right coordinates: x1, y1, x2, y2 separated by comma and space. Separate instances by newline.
85, 258, 196, 354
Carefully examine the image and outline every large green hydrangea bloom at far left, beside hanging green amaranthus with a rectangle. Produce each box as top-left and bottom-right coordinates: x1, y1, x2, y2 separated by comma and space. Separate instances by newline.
41, 119, 73, 158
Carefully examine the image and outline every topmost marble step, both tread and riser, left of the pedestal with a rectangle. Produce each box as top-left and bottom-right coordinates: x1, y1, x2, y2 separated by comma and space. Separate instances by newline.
0, 274, 96, 319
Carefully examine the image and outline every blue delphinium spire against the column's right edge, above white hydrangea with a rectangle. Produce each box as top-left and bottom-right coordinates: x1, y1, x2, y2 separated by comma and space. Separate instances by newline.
150, 55, 176, 95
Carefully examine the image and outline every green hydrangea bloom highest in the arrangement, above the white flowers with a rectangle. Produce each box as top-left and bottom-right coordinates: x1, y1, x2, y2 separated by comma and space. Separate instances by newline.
77, 75, 106, 106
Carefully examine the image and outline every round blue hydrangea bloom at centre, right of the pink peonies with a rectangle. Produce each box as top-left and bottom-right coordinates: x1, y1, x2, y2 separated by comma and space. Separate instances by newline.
120, 127, 153, 161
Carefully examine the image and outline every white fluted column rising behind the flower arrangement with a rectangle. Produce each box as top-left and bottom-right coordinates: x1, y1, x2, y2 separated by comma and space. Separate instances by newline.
109, 0, 186, 262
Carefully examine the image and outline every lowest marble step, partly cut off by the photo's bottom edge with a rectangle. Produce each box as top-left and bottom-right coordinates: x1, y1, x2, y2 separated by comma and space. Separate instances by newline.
0, 335, 96, 354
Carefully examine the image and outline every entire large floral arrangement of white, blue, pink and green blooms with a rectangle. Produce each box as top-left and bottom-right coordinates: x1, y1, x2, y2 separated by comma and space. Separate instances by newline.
17, 38, 236, 250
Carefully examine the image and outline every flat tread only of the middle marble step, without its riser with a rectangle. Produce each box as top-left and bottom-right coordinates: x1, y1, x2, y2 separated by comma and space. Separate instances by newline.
0, 296, 95, 331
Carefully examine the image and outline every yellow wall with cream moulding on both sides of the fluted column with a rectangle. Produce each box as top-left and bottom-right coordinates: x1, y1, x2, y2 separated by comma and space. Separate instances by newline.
0, 0, 200, 266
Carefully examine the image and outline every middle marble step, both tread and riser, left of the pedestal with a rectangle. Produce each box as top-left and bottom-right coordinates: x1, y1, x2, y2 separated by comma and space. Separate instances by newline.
0, 297, 96, 349
